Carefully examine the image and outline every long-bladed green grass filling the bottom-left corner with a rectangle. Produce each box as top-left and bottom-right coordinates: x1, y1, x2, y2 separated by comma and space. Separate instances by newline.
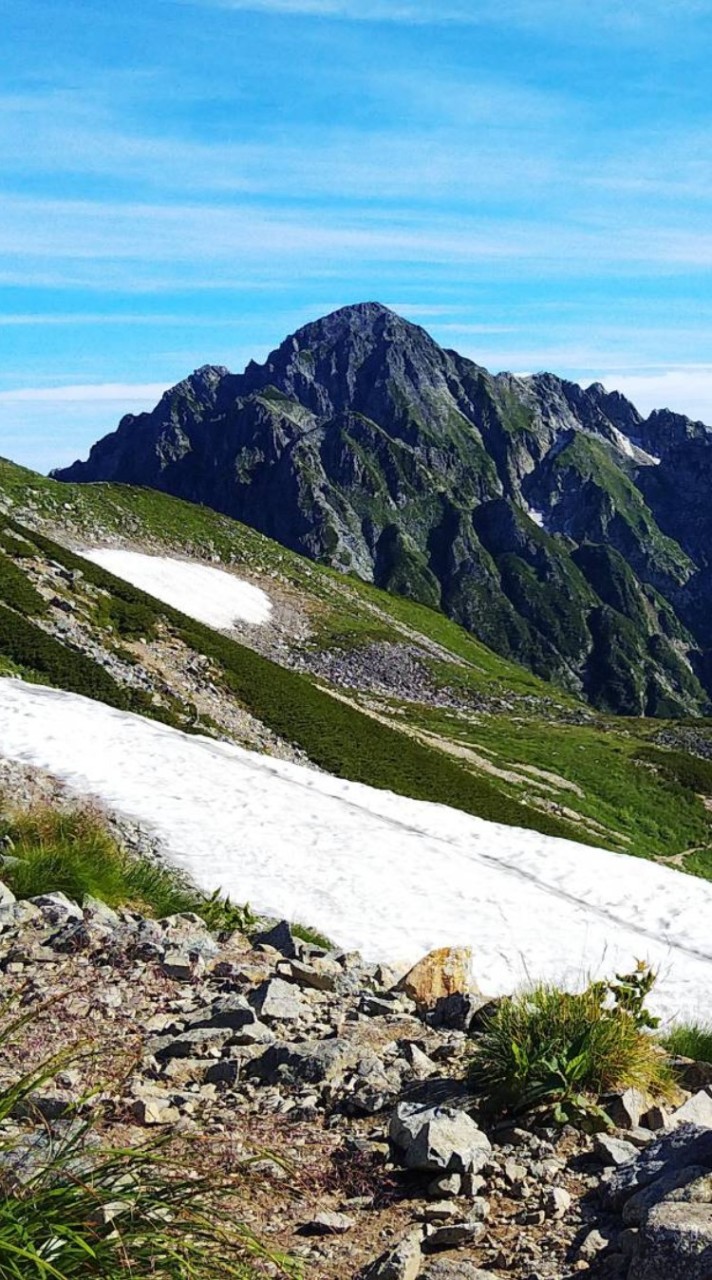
0, 1015, 298, 1280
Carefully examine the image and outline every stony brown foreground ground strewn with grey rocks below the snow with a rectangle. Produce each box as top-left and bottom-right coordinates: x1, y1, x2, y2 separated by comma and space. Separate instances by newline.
0, 890, 712, 1280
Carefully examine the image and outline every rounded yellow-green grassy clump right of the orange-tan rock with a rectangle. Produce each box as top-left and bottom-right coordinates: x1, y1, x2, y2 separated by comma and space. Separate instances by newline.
470, 979, 672, 1124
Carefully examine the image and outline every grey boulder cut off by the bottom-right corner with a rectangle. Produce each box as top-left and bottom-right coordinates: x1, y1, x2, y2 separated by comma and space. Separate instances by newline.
629, 1204, 712, 1280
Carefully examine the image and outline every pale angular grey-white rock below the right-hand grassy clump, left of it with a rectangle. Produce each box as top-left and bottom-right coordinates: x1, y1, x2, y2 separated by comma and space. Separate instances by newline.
389, 1102, 492, 1174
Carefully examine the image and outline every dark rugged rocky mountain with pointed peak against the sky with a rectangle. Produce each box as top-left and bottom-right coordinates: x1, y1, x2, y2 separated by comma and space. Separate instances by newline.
56, 303, 712, 716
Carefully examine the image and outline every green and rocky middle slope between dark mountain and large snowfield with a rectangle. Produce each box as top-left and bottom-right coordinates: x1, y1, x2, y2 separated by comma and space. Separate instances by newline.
0, 463, 712, 877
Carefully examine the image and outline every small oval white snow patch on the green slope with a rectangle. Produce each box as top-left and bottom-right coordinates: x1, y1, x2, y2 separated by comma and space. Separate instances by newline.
81, 547, 271, 630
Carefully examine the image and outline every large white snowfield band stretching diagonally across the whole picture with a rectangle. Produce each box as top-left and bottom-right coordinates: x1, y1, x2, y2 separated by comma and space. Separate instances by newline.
0, 678, 712, 1019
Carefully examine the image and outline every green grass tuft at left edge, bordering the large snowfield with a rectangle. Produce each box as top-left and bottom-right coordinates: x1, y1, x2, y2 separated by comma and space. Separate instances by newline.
0, 805, 255, 932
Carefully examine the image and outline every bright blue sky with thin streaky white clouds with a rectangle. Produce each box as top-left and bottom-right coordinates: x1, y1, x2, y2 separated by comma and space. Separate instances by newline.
0, 0, 712, 470
